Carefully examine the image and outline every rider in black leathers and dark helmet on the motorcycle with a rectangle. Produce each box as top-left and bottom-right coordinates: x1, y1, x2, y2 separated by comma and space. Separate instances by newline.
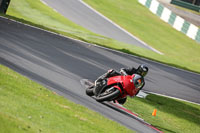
95, 64, 149, 104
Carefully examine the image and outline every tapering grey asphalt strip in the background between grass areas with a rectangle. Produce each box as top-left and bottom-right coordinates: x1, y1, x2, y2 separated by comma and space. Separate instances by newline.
42, 0, 155, 49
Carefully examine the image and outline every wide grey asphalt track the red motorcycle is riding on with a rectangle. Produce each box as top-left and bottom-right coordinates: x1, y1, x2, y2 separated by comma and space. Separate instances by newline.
0, 18, 200, 133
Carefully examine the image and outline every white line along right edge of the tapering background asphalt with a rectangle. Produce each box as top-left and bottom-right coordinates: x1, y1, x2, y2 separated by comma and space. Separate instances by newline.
79, 0, 163, 55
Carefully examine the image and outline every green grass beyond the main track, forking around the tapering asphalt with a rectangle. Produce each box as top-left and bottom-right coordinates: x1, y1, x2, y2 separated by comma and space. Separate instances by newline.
3, 0, 200, 73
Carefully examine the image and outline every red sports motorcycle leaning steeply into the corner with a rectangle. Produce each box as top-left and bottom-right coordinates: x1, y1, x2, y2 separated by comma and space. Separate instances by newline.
86, 74, 144, 102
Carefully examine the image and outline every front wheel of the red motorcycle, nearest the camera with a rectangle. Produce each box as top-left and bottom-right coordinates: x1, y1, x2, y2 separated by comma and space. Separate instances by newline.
96, 87, 120, 102
